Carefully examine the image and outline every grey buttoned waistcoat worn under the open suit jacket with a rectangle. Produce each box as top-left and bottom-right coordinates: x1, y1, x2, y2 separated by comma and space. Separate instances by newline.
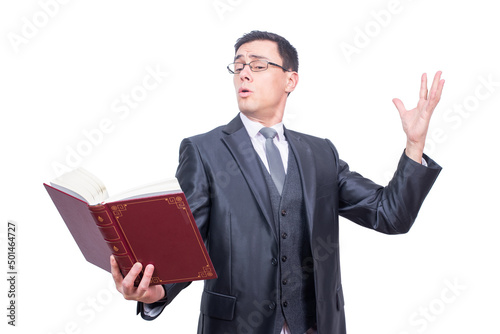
262, 150, 316, 334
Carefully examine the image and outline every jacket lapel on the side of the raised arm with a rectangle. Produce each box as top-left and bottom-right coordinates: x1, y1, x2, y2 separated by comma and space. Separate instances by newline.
285, 129, 316, 237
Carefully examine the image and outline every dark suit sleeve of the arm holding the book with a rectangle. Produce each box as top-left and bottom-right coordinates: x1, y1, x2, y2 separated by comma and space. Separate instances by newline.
137, 139, 210, 320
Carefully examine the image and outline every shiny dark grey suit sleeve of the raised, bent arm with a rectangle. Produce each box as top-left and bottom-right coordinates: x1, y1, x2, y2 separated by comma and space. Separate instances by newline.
330, 143, 441, 234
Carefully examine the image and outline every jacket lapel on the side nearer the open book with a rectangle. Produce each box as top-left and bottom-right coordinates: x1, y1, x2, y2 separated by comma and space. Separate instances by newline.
222, 115, 278, 241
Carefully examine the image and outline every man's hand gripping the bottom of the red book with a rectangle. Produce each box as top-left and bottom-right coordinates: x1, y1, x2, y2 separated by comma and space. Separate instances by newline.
110, 255, 165, 304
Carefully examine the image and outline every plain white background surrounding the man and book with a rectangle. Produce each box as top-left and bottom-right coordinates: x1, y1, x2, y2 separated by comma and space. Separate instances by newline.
0, 0, 500, 334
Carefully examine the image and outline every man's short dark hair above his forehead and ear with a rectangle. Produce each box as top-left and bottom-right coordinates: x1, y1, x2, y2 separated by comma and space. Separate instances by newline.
234, 30, 299, 72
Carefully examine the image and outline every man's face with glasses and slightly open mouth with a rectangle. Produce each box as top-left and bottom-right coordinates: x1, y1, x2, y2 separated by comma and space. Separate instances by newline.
233, 40, 293, 121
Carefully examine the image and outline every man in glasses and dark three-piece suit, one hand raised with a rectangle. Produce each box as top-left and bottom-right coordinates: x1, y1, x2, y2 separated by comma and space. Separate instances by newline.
111, 31, 444, 334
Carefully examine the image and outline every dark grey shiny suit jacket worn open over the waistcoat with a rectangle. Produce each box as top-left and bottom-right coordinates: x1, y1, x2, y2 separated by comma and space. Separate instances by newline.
139, 115, 441, 334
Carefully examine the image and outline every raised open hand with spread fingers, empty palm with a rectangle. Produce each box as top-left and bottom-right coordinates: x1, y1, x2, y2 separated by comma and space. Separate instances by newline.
392, 71, 444, 163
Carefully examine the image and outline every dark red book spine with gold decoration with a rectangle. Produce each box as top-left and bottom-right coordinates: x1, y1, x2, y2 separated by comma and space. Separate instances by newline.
89, 205, 142, 285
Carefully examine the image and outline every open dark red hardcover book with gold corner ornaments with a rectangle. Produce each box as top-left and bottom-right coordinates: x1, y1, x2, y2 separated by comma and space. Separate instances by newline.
44, 168, 217, 285
